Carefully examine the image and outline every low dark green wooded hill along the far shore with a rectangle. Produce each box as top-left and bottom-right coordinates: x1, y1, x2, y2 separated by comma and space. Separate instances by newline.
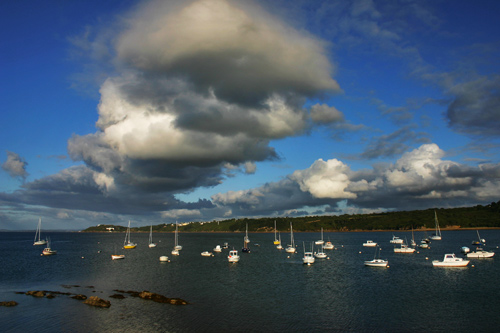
83, 201, 500, 232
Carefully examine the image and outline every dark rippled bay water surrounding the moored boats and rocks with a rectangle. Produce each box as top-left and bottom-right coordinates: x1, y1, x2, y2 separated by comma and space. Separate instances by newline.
0, 230, 500, 332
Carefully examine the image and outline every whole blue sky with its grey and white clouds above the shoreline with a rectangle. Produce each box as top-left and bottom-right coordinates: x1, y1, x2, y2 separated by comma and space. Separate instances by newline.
0, 0, 500, 230
